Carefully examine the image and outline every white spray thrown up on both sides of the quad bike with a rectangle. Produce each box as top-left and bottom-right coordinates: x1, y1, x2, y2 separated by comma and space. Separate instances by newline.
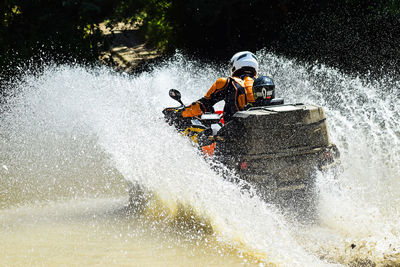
0, 51, 400, 266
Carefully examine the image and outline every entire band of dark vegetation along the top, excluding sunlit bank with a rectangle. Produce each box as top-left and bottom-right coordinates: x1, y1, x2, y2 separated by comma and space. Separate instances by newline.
0, 0, 400, 86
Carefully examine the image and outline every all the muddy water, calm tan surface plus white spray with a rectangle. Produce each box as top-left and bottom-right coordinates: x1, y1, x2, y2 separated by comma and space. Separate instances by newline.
0, 51, 400, 266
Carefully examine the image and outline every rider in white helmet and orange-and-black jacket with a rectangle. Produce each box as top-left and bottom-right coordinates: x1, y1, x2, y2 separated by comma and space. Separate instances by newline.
181, 51, 274, 122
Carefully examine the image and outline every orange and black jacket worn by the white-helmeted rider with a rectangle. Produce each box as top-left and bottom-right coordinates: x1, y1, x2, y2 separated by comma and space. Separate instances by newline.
182, 76, 256, 122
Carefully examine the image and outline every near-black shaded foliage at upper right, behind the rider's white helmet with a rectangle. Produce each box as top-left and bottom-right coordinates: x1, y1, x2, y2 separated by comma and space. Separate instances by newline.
160, 0, 400, 73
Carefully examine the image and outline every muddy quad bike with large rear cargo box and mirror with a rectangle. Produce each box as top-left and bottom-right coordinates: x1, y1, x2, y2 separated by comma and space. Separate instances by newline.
163, 89, 340, 218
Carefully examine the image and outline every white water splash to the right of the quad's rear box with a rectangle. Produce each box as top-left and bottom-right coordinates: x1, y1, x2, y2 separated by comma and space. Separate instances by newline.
261, 52, 400, 265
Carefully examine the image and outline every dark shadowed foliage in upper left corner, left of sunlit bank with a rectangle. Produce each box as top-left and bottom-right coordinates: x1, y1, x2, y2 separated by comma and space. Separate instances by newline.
0, 0, 115, 80
